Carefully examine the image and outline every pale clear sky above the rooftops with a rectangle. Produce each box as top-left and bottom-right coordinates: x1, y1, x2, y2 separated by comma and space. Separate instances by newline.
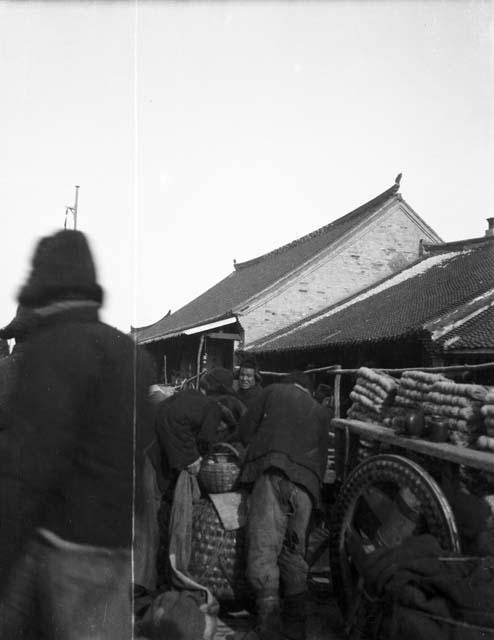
0, 0, 494, 331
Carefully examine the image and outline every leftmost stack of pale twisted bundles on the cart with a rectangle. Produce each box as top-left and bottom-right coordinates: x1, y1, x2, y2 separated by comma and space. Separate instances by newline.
347, 367, 398, 424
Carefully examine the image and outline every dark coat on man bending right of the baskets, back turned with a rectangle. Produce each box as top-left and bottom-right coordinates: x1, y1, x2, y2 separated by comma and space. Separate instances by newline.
240, 384, 329, 504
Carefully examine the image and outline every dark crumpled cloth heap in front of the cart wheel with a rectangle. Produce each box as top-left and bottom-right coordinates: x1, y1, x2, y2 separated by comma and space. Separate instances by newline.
349, 535, 494, 640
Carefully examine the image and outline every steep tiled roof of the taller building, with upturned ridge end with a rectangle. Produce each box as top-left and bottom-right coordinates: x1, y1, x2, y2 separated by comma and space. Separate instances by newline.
134, 184, 406, 343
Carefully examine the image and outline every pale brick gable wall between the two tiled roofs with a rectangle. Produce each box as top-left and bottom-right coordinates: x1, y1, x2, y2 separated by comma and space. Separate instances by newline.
239, 204, 431, 345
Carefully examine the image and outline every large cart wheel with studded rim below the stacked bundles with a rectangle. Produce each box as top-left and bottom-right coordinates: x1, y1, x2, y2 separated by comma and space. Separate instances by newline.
329, 455, 460, 638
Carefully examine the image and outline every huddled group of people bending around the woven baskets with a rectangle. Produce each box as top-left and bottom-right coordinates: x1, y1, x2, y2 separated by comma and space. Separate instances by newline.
141, 357, 331, 640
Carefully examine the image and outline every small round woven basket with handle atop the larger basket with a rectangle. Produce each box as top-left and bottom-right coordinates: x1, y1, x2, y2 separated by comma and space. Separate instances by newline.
199, 442, 240, 493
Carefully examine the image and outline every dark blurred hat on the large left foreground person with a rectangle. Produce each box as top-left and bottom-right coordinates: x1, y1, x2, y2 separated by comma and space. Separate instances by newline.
18, 230, 103, 307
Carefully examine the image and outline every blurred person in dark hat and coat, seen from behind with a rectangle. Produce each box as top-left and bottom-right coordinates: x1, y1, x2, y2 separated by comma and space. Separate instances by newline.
0, 230, 152, 640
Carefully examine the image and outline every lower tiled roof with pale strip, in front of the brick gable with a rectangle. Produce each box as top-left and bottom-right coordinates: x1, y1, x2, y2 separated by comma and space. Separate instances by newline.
251, 239, 494, 352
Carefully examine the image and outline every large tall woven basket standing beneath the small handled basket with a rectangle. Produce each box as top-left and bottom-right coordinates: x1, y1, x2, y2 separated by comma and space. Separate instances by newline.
189, 498, 251, 602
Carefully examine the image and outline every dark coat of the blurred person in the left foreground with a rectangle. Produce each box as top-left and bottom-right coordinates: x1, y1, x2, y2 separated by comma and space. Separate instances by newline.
0, 305, 152, 586
